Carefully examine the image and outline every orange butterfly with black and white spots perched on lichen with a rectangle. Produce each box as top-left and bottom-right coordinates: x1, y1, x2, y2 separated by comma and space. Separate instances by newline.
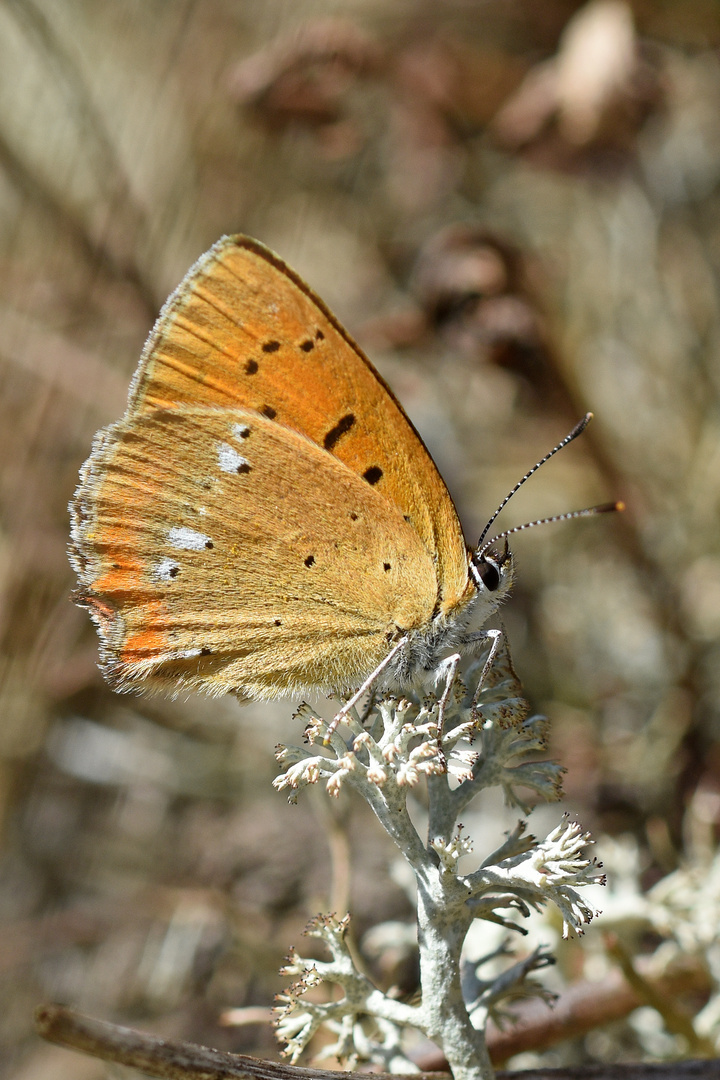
70, 235, 613, 699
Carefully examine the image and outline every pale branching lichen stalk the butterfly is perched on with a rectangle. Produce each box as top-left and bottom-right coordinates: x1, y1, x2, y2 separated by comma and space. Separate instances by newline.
269, 637, 602, 1080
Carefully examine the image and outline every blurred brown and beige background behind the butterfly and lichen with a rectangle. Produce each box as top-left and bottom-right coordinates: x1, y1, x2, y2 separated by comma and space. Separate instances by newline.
0, 0, 720, 1080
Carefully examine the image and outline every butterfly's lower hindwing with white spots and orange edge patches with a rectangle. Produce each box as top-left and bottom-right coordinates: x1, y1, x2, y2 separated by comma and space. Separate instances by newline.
72, 405, 436, 698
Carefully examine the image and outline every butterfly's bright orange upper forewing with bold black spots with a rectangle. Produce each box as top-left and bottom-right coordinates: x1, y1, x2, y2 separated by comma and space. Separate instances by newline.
127, 237, 472, 613
